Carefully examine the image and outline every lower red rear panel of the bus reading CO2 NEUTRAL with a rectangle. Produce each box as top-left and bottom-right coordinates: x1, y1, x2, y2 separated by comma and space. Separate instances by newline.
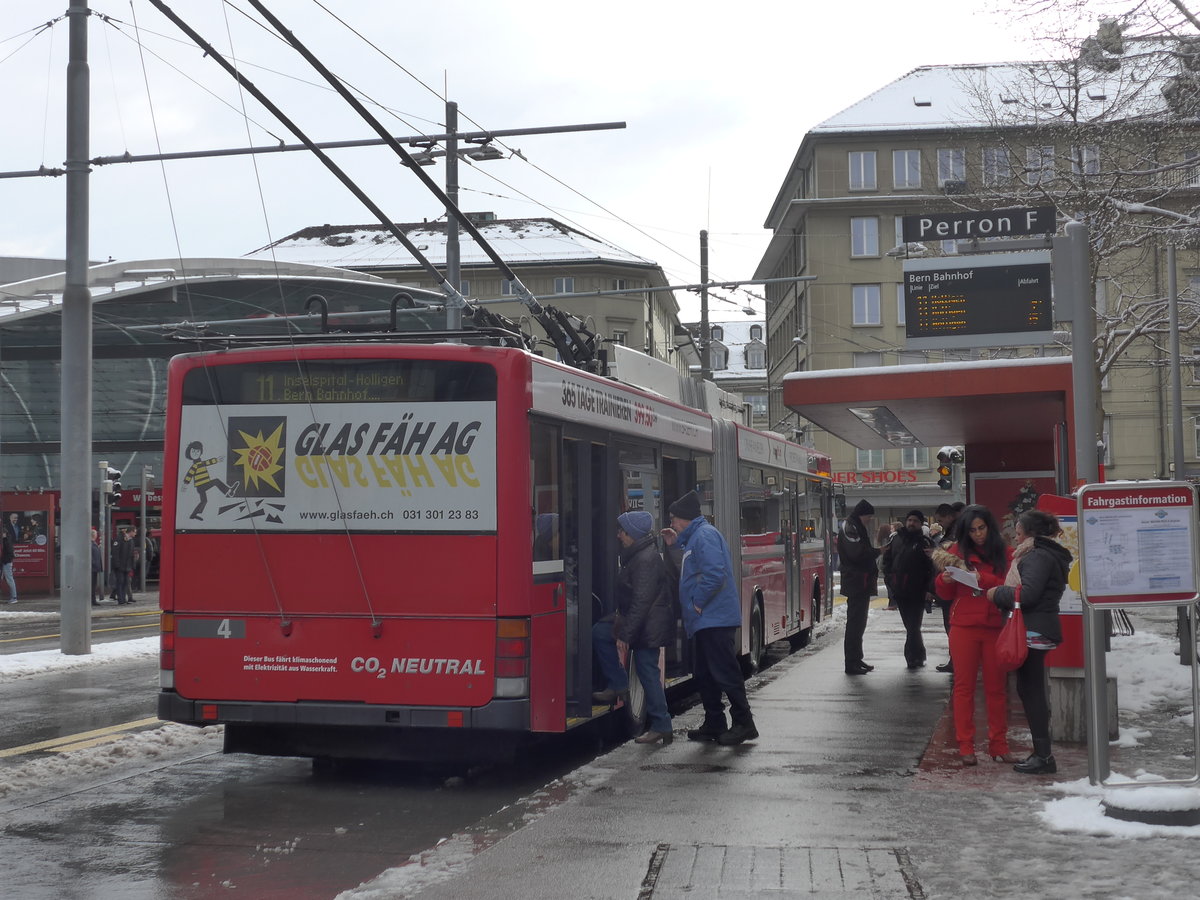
175, 616, 496, 707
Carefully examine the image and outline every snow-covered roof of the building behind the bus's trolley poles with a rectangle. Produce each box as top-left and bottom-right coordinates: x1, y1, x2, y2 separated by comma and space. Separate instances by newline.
246, 218, 656, 269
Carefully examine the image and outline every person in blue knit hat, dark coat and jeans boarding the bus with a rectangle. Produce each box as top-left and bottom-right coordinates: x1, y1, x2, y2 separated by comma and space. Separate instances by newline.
592, 510, 676, 744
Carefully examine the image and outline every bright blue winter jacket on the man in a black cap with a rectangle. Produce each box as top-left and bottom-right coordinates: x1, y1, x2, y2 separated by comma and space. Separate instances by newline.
670, 516, 742, 637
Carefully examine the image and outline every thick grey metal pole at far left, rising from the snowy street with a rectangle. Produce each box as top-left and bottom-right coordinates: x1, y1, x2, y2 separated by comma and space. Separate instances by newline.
59, 0, 91, 655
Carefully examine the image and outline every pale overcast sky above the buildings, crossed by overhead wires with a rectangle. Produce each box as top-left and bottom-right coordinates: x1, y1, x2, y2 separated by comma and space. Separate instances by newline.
0, 0, 1038, 317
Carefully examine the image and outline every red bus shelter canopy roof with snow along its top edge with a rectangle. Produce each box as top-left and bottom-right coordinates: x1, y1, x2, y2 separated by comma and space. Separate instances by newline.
784, 358, 1072, 450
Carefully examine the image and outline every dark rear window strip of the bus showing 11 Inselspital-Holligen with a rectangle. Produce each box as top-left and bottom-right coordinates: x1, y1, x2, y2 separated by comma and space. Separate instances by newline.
182, 359, 496, 406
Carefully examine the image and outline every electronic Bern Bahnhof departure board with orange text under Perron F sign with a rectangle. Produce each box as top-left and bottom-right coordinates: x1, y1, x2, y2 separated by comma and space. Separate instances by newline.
904, 251, 1054, 349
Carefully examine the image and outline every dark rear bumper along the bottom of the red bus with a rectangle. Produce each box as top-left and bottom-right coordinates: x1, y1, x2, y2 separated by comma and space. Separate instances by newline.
158, 691, 529, 761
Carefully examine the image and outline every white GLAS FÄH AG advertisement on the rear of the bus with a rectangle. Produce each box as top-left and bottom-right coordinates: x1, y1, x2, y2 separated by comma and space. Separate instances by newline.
175, 401, 496, 532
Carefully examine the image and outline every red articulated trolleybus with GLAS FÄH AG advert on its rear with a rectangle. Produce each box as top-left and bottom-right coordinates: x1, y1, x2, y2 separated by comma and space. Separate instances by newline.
158, 335, 832, 760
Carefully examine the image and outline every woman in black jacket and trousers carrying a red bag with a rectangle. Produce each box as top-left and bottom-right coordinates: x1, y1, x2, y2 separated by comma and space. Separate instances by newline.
988, 509, 1072, 775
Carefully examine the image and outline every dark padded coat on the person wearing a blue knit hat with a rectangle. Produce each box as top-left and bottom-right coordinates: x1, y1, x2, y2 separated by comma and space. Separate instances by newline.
612, 534, 676, 649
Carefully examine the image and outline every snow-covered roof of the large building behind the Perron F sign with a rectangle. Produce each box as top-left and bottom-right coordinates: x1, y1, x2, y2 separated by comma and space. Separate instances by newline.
811, 41, 1180, 134
